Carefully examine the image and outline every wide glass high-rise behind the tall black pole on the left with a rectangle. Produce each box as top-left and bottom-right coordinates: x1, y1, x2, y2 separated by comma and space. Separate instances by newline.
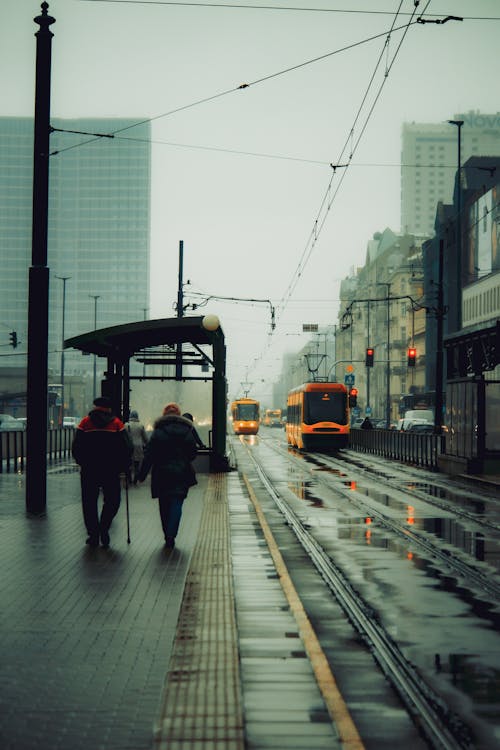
0, 117, 151, 382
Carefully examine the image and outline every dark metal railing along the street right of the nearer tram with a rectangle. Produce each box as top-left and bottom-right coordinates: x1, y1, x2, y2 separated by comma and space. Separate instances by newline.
349, 430, 445, 469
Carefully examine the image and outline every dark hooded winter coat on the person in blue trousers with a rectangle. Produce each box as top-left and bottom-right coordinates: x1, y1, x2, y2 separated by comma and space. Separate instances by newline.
138, 414, 197, 497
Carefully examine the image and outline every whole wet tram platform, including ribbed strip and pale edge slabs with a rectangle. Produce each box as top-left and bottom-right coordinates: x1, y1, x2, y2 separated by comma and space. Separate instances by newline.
0, 462, 344, 750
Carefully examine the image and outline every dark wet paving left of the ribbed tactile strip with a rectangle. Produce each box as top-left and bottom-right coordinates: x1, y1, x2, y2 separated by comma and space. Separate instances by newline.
0, 470, 205, 750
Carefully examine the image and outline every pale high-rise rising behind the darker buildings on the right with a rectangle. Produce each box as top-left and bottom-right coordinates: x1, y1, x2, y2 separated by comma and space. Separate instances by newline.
401, 111, 500, 237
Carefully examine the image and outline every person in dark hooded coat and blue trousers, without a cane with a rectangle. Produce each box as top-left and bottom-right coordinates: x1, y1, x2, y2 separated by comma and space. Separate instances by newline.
138, 403, 197, 549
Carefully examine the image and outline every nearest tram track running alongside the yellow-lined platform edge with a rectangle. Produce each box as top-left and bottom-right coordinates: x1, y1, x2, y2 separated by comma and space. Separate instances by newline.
240, 440, 473, 750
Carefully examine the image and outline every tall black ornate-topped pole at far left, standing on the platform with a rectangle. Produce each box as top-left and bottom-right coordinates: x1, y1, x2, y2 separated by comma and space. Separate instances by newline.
26, 2, 55, 515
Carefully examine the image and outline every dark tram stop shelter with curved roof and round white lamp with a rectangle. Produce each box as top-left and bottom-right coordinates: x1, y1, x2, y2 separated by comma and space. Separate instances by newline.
64, 315, 228, 472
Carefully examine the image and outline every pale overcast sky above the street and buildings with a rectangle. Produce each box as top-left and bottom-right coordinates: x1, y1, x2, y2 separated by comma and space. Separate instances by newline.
0, 0, 500, 396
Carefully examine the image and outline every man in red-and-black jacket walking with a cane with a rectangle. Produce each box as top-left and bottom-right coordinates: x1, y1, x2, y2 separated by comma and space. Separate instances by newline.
71, 396, 132, 548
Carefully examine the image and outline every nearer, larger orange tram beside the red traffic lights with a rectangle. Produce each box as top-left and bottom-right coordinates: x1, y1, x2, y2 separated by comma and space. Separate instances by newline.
286, 382, 349, 451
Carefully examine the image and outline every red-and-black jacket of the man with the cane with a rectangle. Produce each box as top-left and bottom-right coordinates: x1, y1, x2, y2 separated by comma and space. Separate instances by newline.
71, 409, 132, 476
